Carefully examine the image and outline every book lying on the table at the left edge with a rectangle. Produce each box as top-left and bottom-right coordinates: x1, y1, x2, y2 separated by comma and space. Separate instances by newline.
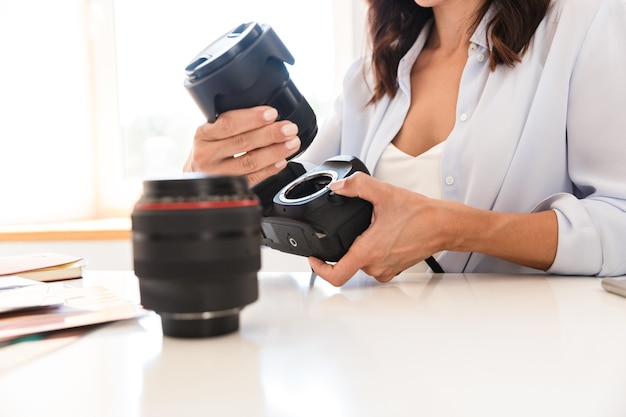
0, 253, 85, 282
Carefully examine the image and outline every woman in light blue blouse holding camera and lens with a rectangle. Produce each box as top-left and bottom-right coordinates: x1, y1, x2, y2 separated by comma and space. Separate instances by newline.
186, 0, 626, 285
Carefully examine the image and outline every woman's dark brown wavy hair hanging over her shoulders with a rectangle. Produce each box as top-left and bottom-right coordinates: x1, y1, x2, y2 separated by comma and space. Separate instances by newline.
368, 0, 550, 103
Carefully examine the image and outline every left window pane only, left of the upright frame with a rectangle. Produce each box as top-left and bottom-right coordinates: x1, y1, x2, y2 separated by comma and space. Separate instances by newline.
0, 0, 95, 224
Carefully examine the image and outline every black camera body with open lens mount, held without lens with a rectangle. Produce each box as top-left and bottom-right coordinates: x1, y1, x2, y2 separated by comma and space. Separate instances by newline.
261, 155, 372, 262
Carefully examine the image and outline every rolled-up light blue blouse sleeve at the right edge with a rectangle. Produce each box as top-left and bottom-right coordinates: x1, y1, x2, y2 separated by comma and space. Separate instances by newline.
536, 0, 626, 276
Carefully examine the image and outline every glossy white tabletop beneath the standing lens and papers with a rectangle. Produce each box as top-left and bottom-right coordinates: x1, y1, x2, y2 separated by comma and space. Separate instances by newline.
0, 272, 626, 417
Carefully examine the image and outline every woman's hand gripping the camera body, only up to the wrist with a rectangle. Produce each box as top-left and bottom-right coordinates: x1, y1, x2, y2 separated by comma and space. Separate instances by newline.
309, 173, 447, 286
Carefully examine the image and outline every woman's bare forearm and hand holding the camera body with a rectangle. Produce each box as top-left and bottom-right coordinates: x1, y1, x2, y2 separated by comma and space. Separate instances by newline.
309, 173, 558, 286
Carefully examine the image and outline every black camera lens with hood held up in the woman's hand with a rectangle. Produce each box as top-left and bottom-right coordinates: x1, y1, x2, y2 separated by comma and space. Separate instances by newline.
185, 22, 317, 158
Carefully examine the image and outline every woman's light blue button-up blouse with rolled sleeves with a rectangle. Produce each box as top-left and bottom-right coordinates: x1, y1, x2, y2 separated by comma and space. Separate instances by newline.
301, 0, 626, 276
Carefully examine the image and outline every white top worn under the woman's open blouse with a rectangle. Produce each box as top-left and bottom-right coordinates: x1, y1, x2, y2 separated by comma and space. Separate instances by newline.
373, 142, 445, 272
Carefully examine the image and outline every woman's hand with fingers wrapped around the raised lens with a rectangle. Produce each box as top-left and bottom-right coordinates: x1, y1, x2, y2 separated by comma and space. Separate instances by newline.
184, 106, 300, 185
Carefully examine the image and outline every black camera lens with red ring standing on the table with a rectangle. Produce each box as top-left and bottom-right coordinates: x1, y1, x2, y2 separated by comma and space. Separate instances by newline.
131, 174, 261, 337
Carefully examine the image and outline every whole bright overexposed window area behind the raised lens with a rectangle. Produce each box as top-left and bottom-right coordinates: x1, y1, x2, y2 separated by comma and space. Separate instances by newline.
0, 0, 364, 224
